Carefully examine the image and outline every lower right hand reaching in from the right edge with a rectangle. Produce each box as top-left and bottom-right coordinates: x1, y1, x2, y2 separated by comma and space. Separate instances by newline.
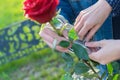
85, 40, 120, 64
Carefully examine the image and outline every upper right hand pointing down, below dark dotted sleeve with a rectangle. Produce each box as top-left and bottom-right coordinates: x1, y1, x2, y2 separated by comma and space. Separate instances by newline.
74, 0, 112, 41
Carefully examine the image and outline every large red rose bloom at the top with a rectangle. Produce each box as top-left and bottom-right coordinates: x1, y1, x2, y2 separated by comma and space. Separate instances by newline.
23, 0, 59, 23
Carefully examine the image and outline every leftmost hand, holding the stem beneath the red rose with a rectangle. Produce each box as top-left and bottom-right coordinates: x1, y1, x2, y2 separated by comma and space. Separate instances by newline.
39, 24, 69, 52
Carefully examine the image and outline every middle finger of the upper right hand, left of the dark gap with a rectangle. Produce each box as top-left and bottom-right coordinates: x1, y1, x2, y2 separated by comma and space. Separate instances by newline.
78, 23, 92, 40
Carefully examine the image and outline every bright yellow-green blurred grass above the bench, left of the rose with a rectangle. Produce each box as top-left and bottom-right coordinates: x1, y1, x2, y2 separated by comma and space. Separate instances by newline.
0, 0, 25, 29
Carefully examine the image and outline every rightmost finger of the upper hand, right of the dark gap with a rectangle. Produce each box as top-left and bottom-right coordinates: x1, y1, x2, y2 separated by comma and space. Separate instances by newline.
85, 25, 100, 42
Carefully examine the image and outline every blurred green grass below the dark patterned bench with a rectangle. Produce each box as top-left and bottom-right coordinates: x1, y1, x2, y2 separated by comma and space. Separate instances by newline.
0, 48, 64, 80
